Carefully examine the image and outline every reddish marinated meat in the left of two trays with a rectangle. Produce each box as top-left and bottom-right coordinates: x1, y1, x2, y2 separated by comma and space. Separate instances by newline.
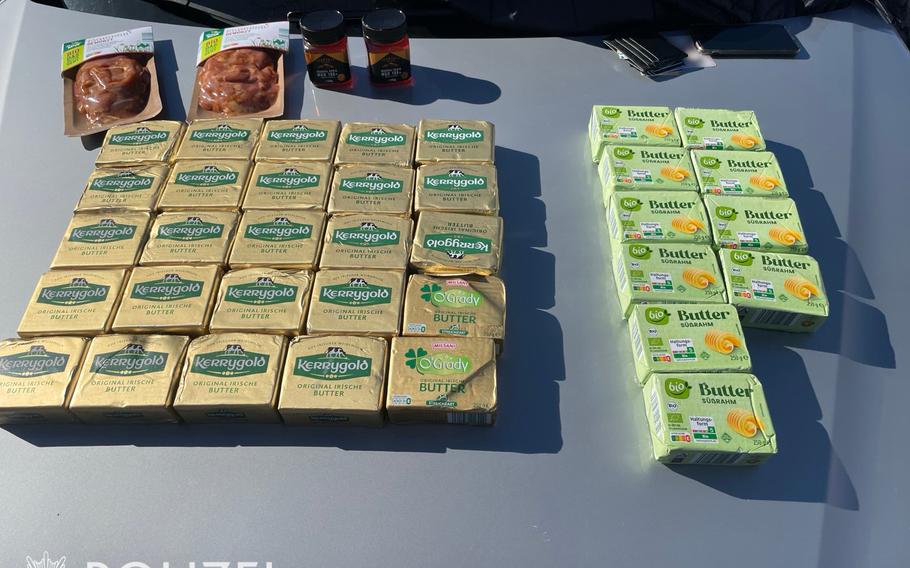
73, 55, 151, 124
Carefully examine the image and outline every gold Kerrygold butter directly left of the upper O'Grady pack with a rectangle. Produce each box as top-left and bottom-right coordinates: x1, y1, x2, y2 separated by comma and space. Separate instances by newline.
307, 270, 404, 337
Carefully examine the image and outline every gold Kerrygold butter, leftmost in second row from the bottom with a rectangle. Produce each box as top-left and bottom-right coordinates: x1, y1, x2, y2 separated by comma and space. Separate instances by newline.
19, 269, 127, 337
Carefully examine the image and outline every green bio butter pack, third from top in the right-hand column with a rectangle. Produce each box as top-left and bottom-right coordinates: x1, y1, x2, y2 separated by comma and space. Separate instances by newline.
705, 195, 809, 254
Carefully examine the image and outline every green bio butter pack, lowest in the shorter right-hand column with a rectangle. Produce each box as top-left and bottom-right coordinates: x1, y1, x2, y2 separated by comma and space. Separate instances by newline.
720, 249, 829, 331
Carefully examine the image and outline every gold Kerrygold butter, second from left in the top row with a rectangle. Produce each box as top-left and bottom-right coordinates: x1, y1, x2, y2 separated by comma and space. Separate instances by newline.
177, 118, 262, 160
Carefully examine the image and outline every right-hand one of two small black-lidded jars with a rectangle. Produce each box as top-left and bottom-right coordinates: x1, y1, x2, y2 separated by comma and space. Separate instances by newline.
361, 9, 413, 86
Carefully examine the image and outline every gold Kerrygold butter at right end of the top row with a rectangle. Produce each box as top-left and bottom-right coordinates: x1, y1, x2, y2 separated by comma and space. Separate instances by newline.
416, 119, 495, 164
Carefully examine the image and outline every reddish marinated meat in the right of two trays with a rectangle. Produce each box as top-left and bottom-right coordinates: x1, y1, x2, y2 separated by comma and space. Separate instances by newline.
198, 47, 278, 116
